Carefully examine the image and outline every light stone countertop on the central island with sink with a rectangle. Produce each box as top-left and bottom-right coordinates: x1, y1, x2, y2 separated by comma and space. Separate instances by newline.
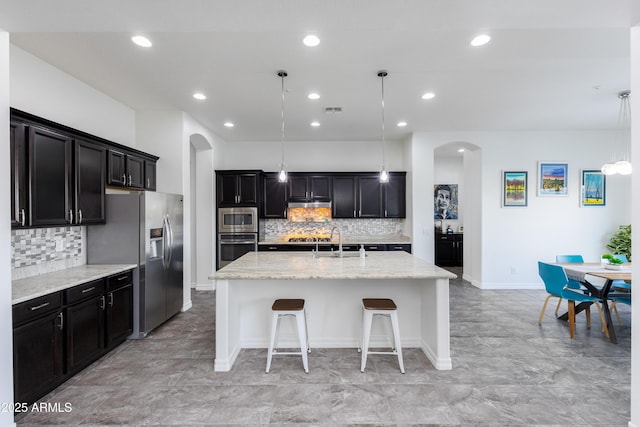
209, 251, 457, 280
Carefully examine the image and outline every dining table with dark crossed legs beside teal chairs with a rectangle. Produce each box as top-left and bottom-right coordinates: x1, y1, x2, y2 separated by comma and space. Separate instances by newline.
557, 262, 631, 344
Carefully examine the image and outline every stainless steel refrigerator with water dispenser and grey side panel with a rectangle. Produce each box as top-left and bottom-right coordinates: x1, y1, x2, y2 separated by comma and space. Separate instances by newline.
87, 191, 183, 339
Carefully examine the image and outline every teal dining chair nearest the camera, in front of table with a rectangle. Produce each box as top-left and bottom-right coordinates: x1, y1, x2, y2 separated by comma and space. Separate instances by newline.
538, 261, 606, 339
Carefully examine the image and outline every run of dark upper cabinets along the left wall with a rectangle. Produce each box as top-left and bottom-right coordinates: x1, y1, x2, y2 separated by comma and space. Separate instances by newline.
10, 109, 157, 228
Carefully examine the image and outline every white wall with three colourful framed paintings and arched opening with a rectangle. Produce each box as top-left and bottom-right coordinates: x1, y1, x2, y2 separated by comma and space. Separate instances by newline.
413, 131, 631, 288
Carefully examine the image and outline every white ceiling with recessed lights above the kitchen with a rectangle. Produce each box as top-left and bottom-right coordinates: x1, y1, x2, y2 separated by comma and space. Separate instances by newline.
0, 0, 640, 145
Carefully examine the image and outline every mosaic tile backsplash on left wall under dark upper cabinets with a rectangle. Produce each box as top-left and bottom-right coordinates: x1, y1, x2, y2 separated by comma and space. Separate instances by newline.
11, 227, 86, 280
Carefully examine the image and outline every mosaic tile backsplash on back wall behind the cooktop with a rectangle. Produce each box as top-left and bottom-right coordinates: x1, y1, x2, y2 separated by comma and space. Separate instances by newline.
261, 218, 404, 240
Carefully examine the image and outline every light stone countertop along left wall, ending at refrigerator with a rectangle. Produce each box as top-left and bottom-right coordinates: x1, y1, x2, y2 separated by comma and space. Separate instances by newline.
11, 264, 137, 304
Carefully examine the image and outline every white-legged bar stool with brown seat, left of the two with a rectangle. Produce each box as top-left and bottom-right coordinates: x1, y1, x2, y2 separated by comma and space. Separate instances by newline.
266, 299, 311, 374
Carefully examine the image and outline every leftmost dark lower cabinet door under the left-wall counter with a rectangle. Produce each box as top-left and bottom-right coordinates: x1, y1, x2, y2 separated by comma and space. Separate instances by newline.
13, 312, 63, 403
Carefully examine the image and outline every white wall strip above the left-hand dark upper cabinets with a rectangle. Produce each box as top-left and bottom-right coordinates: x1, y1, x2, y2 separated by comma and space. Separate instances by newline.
10, 45, 135, 147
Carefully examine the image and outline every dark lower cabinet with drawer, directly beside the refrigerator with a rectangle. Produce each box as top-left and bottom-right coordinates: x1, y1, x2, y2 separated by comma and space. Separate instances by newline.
105, 271, 133, 349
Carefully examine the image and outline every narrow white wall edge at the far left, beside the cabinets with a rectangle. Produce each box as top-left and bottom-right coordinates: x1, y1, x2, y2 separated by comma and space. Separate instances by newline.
0, 30, 14, 426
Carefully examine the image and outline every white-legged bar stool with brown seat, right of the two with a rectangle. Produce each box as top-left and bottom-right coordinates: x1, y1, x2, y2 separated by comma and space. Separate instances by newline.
360, 298, 404, 374
